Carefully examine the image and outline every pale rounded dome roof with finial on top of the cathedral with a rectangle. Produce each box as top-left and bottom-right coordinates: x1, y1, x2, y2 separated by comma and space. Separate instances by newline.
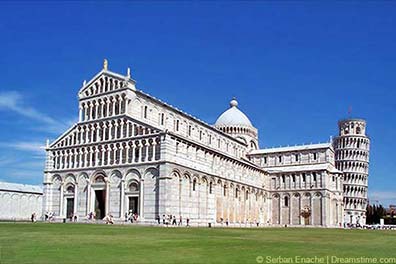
215, 98, 253, 127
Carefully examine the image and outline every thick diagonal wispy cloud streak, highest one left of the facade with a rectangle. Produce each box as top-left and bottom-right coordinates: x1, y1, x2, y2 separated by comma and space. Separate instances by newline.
0, 91, 69, 133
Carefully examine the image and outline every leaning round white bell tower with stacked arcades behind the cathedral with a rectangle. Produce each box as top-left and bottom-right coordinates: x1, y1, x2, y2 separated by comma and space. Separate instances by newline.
333, 119, 370, 225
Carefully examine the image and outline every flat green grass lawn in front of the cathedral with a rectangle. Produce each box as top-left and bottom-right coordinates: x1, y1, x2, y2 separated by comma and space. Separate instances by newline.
0, 223, 396, 264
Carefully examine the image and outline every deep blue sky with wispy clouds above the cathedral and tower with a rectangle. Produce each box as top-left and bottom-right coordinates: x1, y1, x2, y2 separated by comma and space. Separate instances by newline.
0, 1, 396, 205
